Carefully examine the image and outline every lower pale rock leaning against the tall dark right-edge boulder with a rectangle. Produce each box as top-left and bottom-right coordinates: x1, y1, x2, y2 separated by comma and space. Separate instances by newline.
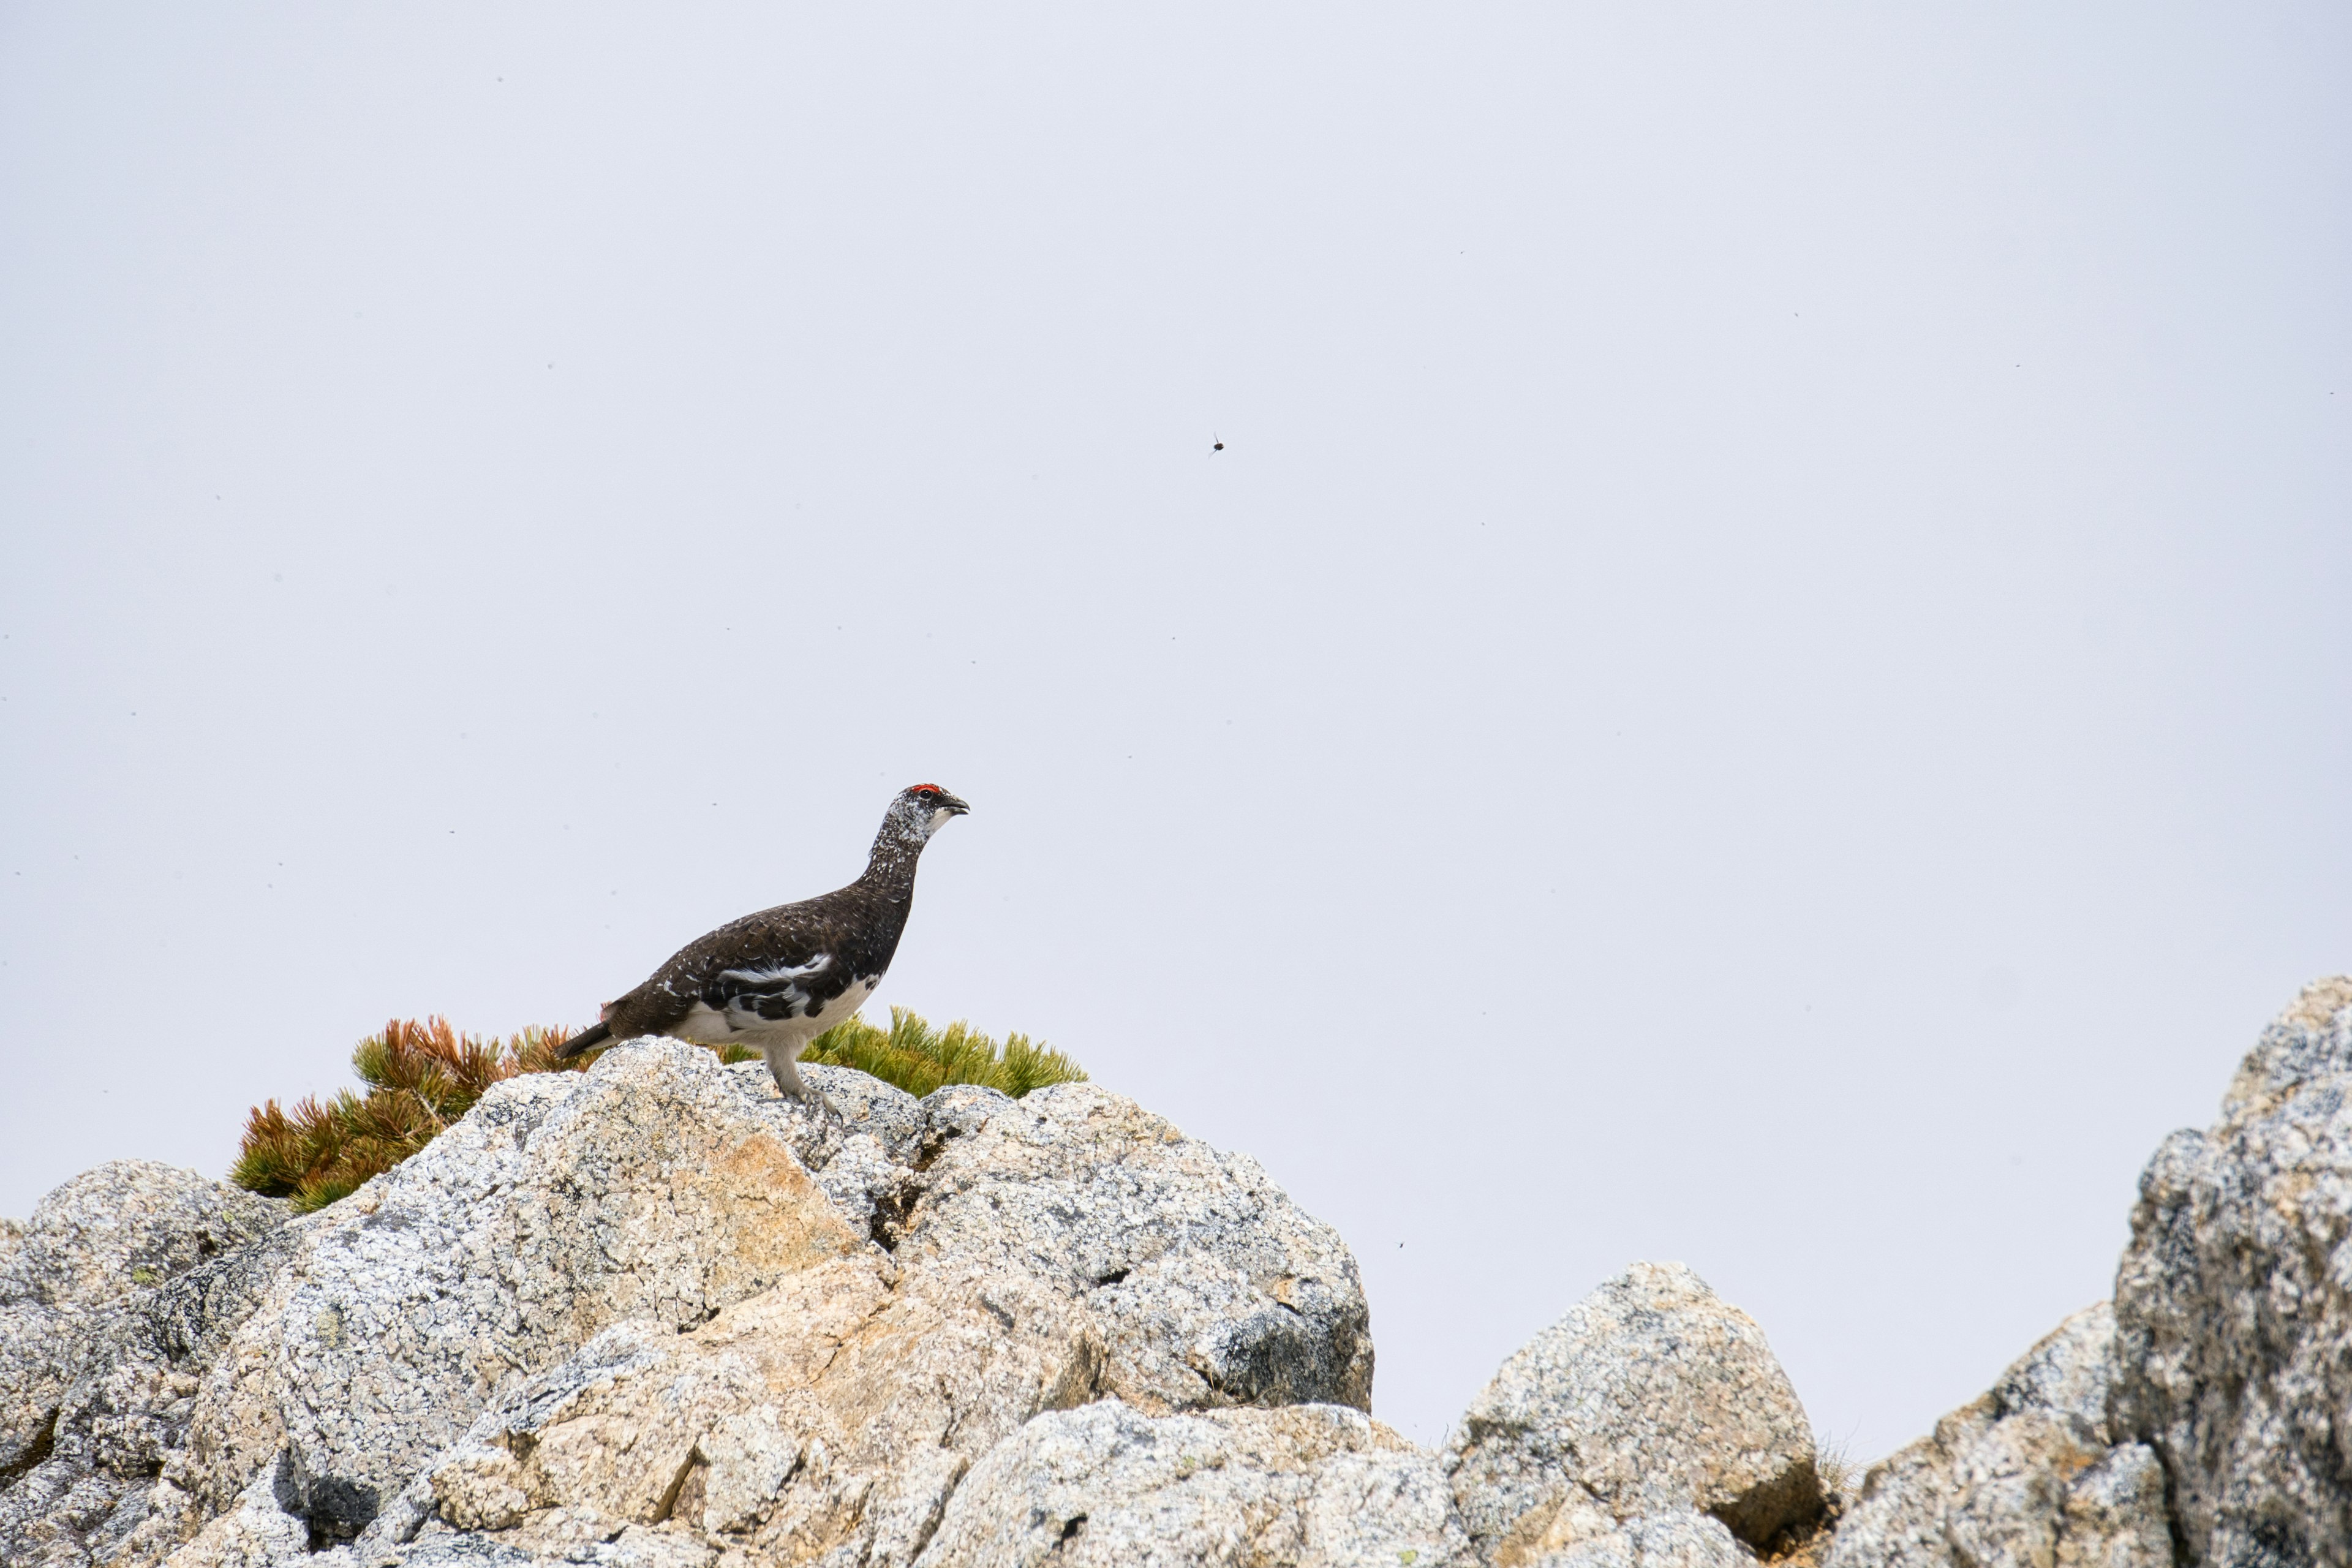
1828, 1302, 2173, 1568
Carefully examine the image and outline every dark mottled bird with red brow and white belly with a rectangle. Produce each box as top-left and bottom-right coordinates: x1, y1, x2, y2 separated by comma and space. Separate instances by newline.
555, 785, 971, 1114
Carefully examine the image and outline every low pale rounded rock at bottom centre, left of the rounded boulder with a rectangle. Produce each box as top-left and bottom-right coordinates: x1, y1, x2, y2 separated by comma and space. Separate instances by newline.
918, 1399, 1477, 1568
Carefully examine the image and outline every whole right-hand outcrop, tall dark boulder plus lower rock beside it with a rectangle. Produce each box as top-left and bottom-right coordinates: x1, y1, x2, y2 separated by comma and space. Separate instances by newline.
1830, 978, 2352, 1568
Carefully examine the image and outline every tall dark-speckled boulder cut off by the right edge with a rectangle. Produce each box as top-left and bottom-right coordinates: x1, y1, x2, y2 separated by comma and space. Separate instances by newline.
2112, 976, 2352, 1568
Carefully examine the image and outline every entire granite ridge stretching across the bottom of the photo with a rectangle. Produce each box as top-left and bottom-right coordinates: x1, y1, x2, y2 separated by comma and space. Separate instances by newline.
13, 980, 2352, 1568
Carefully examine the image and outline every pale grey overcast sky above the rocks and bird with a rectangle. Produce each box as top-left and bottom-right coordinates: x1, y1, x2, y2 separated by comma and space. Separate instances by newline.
0, 2, 2352, 1455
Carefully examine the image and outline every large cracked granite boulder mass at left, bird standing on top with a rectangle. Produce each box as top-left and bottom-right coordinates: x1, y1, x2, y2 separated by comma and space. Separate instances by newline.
0, 1041, 1395, 1568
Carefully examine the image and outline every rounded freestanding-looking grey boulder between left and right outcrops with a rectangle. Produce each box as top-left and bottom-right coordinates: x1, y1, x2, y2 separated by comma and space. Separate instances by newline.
1447, 1262, 1823, 1563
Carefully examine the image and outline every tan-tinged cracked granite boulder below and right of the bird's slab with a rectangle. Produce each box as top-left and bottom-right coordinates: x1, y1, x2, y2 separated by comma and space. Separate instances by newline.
358, 1084, 1371, 1568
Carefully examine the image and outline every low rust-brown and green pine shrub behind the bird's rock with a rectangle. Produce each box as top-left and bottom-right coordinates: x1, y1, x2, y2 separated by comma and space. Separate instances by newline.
228, 1006, 1087, 1213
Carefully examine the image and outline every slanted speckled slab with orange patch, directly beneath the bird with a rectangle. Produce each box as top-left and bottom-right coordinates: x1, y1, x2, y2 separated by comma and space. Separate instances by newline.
165, 1041, 868, 1542
